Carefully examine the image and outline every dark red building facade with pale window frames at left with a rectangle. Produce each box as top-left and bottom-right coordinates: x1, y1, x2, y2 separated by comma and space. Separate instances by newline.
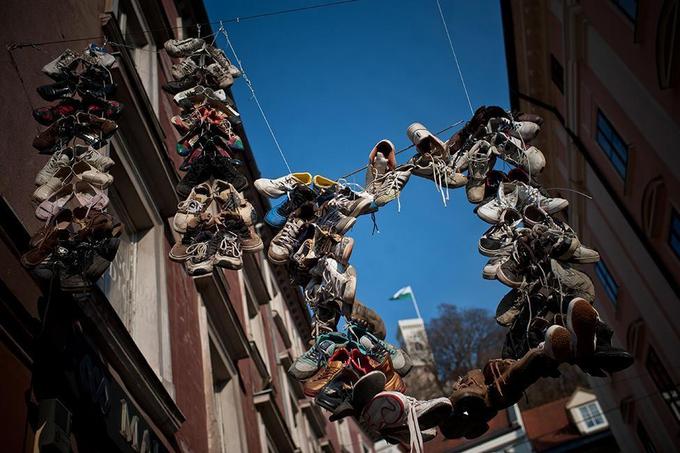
0, 0, 373, 453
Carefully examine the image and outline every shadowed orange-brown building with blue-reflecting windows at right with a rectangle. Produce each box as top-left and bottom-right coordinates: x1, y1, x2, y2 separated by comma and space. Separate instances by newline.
500, 0, 680, 452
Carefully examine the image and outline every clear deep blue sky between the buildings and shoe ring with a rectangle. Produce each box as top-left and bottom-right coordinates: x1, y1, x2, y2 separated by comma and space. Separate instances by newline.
206, 0, 508, 339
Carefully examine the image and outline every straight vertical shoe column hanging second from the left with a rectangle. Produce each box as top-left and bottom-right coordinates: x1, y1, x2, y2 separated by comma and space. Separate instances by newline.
163, 38, 263, 276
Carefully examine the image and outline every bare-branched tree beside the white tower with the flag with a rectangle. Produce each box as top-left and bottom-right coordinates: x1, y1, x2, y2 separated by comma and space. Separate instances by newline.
427, 304, 505, 389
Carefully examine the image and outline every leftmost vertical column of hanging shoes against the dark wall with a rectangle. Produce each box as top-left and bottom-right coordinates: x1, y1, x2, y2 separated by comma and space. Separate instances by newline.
21, 44, 123, 291
